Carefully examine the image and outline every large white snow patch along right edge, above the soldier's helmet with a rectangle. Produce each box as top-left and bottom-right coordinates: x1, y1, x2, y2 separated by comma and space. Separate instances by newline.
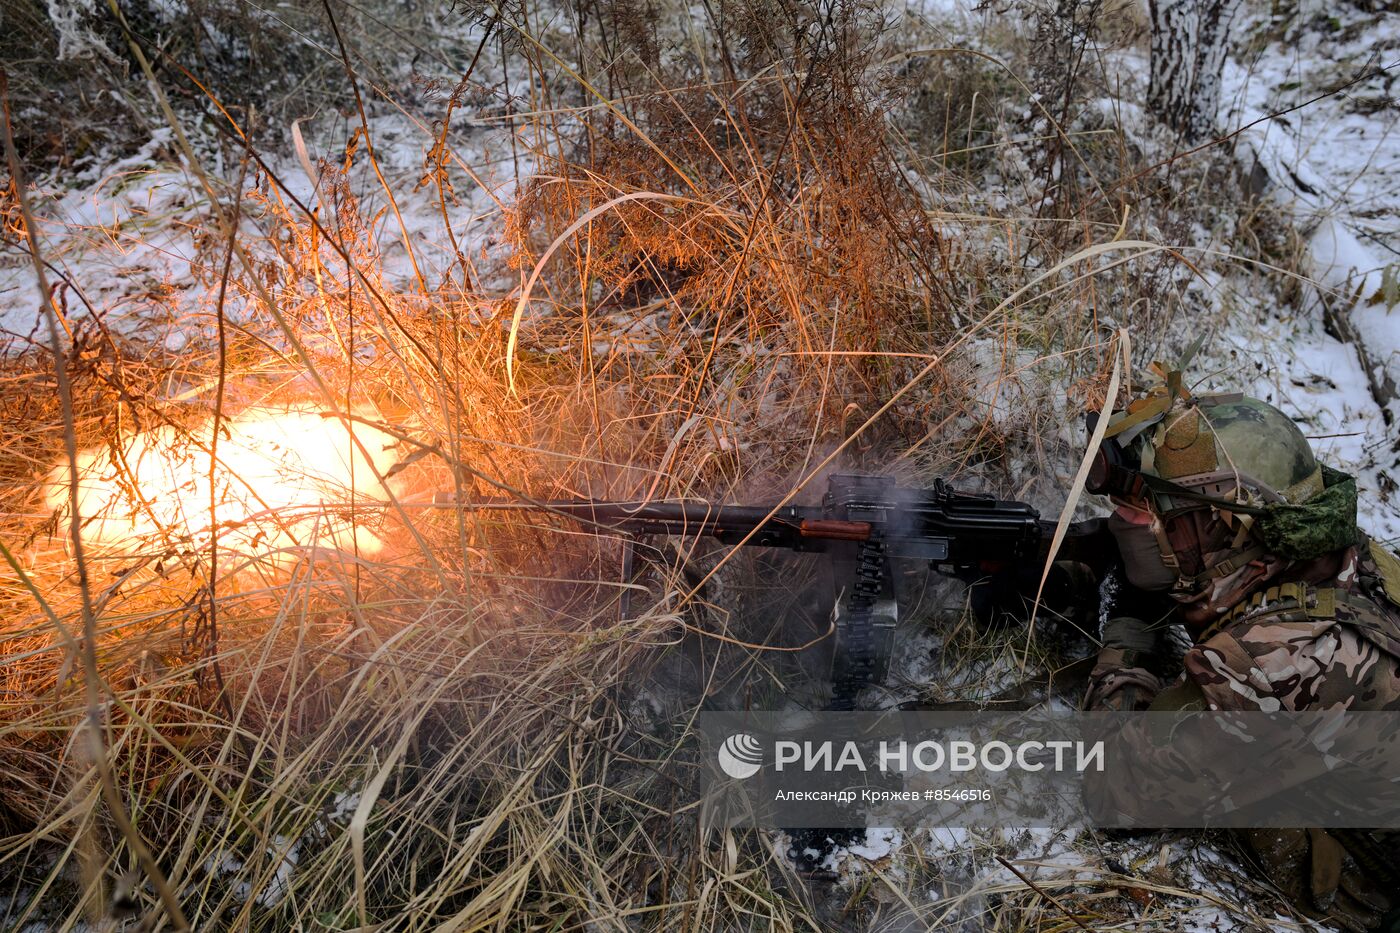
1222, 0, 1400, 546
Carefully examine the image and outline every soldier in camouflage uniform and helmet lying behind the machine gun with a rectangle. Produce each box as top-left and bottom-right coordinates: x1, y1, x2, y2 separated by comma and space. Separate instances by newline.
1085, 373, 1400, 933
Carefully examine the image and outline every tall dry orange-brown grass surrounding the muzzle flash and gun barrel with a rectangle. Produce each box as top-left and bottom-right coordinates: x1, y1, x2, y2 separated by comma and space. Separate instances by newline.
0, 1, 1282, 930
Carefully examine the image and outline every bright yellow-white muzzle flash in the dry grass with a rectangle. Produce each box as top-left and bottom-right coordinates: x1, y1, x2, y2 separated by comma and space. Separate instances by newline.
45, 408, 403, 565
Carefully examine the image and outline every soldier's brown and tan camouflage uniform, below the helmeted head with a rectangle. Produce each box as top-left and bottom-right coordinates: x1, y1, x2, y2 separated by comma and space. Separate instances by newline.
1086, 541, 1400, 933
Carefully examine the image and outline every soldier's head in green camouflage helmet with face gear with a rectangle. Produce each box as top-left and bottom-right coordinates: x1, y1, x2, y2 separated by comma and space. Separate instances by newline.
1088, 353, 1357, 594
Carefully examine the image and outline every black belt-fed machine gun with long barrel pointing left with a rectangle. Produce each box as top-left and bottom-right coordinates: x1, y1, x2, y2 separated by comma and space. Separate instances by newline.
431, 475, 1117, 709
